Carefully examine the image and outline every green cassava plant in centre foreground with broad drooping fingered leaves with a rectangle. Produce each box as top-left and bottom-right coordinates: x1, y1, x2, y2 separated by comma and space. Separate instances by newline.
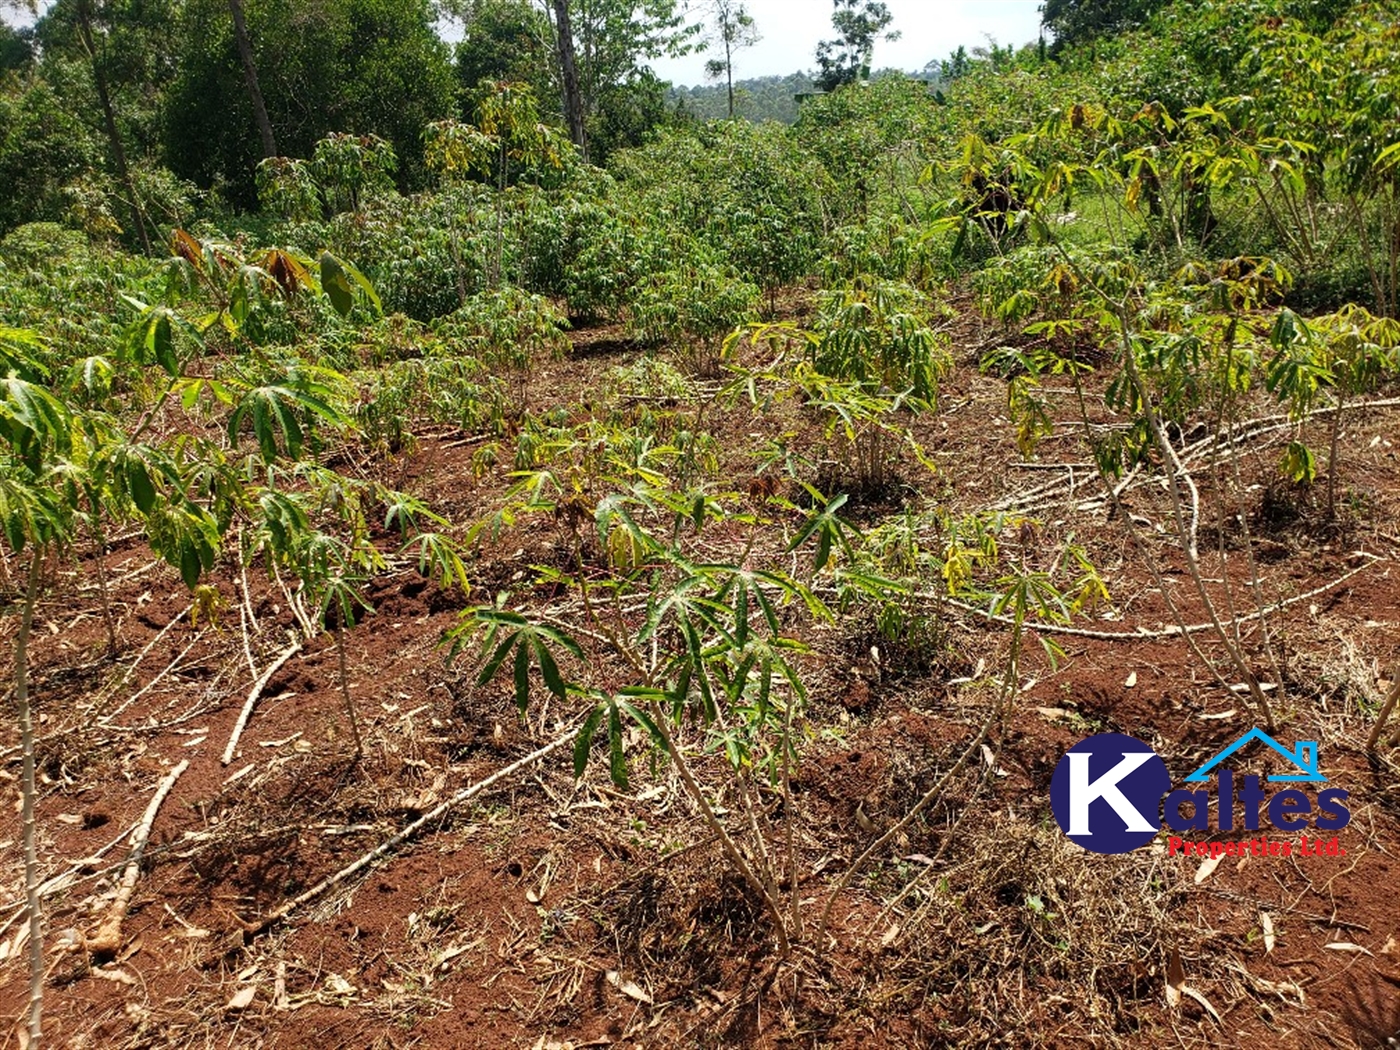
454, 448, 839, 956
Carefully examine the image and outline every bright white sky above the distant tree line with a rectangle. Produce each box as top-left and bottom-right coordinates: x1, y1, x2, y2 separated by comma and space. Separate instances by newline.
651, 0, 1043, 87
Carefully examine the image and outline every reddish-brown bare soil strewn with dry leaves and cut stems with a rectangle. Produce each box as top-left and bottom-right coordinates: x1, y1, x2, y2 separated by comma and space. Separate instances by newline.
0, 299, 1400, 1050
